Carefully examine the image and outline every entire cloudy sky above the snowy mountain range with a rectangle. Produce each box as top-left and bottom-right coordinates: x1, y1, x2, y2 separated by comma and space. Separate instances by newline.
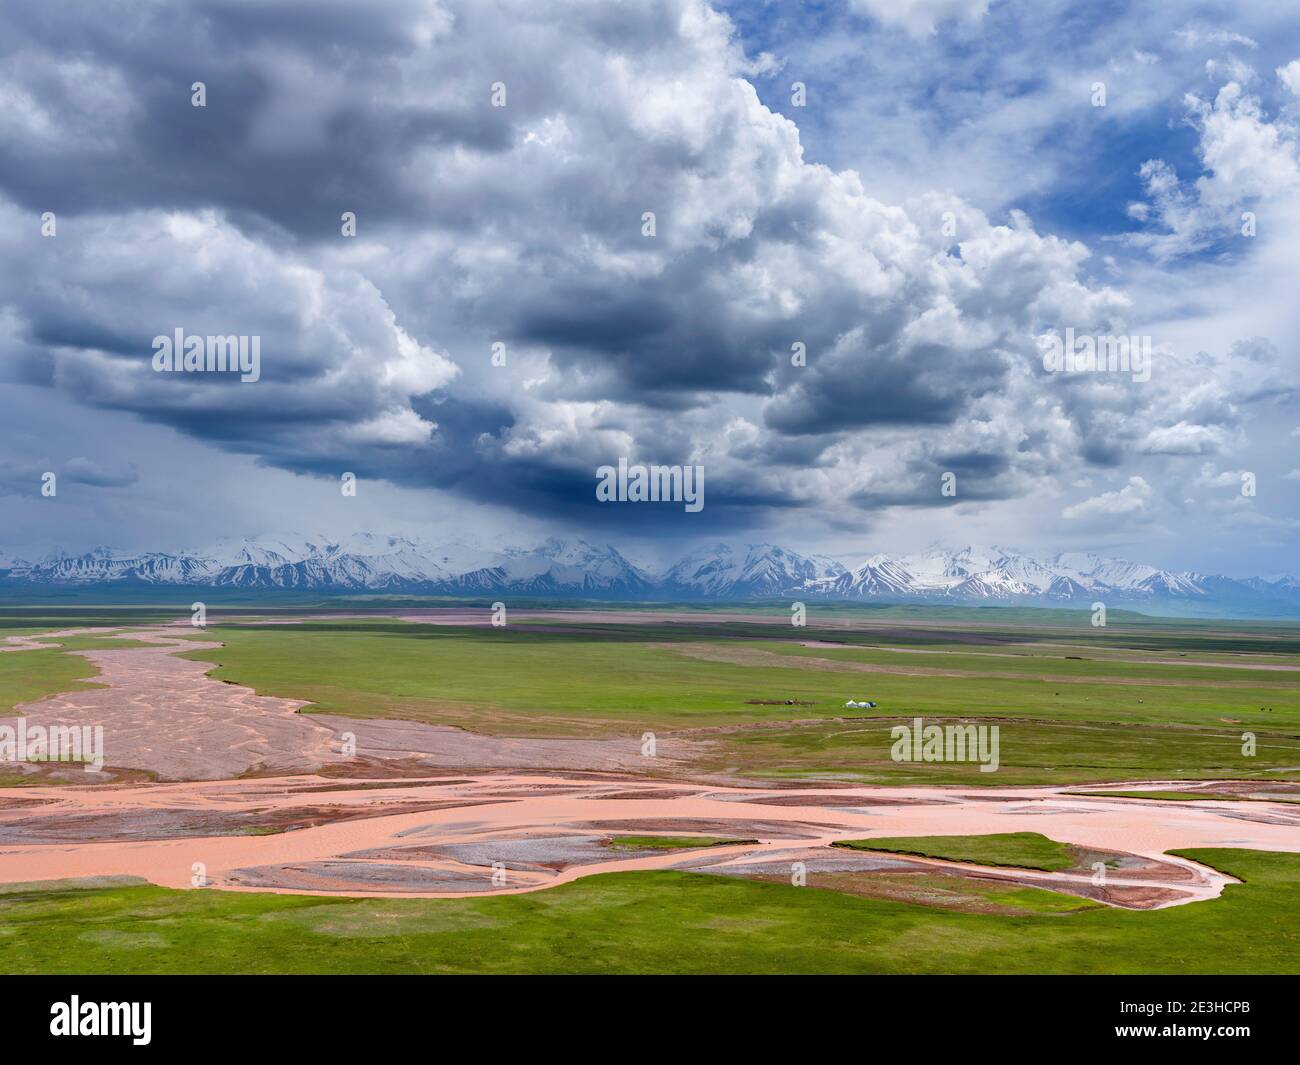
0, 0, 1300, 576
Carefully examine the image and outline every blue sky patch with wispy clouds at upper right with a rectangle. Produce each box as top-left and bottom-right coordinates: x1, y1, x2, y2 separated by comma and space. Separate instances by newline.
722, 3, 1300, 248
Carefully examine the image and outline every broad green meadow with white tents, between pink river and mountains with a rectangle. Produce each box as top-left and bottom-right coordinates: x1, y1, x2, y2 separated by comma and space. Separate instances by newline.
159, 619, 1300, 785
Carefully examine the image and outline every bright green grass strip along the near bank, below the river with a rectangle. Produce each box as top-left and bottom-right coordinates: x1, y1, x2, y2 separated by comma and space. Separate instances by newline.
0, 850, 1300, 974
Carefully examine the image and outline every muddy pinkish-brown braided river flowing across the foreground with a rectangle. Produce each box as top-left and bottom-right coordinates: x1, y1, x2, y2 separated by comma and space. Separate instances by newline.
0, 772, 1300, 905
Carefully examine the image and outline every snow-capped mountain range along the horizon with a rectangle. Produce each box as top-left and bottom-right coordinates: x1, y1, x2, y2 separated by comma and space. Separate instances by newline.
0, 533, 1300, 616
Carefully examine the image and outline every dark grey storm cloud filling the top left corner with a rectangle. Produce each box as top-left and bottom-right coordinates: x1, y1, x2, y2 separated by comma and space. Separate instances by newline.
0, 0, 511, 237
